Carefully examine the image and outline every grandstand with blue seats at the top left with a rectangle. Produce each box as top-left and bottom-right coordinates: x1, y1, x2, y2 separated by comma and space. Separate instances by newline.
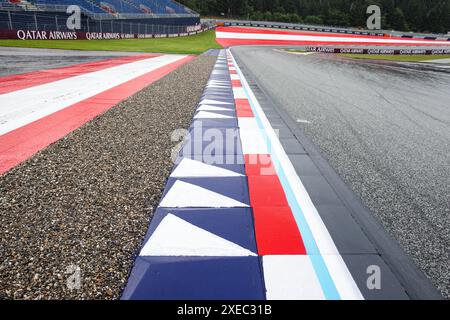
0, 0, 200, 34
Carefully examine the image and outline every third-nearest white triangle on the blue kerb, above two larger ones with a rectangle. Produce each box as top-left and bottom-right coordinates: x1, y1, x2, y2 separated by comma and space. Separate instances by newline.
171, 158, 242, 178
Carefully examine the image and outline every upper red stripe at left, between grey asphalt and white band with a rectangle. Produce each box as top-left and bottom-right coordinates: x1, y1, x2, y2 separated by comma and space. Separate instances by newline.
0, 54, 161, 94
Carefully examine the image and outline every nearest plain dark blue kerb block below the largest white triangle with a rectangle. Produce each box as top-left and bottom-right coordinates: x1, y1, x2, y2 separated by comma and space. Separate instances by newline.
123, 257, 265, 300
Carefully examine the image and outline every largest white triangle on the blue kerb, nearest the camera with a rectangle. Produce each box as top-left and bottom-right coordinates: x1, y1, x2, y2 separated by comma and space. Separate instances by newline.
140, 214, 256, 257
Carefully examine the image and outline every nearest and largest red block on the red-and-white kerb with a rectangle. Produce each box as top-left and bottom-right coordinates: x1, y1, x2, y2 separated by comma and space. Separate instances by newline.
252, 207, 306, 256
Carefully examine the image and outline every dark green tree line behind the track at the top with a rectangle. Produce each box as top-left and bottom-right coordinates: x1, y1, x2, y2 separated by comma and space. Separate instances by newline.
178, 0, 450, 33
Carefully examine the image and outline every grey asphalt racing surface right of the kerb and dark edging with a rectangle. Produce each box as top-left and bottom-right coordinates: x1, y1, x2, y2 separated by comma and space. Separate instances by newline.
232, 47, 450, 298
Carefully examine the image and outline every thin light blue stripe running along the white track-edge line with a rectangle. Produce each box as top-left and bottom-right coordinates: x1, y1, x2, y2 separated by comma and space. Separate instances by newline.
233, 51, 341, 300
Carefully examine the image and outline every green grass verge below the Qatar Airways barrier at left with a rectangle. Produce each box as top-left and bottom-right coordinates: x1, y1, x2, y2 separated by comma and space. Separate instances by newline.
0, 30, 222, 54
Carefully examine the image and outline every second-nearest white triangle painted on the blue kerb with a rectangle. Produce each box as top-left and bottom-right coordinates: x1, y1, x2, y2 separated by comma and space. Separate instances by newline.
160, 180, 248, 208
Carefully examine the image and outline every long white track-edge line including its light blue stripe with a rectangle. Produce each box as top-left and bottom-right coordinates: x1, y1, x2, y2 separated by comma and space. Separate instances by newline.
227, 50, 364, 300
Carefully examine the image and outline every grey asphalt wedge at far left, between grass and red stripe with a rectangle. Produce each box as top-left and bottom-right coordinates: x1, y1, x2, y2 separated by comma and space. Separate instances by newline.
0, 47, 137, 77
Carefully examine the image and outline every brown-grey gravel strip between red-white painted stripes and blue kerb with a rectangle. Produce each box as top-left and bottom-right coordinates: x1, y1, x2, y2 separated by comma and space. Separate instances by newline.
0, 56, 216, 299
